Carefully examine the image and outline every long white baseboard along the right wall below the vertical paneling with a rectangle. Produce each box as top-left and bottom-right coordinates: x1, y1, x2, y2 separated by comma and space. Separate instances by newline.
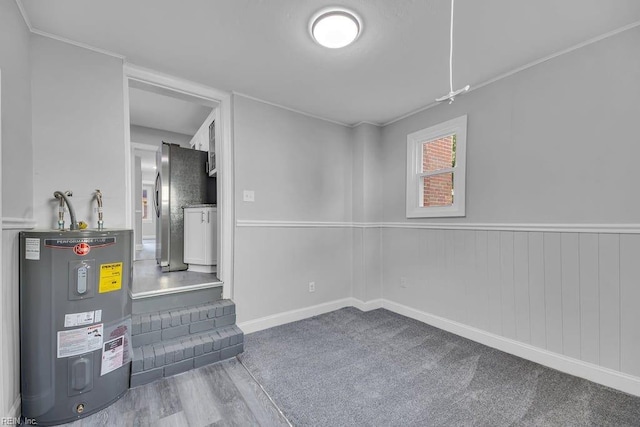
383, 299, 640, 396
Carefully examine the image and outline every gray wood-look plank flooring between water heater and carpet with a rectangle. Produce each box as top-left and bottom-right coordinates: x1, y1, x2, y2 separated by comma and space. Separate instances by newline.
61, 358, 290, 427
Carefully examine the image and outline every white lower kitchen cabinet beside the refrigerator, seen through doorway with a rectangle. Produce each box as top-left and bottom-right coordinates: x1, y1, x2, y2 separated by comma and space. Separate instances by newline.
184, 206, 218, 273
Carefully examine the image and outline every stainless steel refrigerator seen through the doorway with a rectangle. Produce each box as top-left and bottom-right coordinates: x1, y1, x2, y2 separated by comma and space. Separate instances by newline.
154, 142, 216, 272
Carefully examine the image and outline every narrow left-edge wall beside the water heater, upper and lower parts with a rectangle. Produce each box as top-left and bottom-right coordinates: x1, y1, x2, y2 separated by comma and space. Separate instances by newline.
0, 1, 33, 417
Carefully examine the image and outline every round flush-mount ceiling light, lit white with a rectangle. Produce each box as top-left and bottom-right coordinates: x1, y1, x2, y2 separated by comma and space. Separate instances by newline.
309, 8, 362, 49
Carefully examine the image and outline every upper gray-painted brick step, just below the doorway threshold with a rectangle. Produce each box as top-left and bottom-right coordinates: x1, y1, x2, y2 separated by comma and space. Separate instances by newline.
131, 300, 236, 348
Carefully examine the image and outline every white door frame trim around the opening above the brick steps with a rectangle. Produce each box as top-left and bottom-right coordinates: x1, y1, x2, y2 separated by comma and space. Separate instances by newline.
123, 63, 235, 298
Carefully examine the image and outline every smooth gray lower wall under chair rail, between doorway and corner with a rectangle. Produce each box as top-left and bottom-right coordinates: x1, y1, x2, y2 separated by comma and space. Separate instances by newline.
233, 227, 353, 322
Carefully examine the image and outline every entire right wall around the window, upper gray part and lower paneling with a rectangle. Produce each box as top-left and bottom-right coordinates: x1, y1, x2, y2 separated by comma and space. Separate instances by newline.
382, 28, 640, 382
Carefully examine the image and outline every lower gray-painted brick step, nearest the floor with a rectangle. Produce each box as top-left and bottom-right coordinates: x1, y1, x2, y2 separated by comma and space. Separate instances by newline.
131, 326, 244, 387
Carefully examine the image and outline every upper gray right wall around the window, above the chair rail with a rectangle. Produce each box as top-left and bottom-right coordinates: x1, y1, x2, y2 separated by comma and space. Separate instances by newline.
383, 28, 640, 224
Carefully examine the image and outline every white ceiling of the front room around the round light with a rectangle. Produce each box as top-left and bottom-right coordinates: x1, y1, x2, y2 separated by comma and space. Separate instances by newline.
17, 0, 640, 124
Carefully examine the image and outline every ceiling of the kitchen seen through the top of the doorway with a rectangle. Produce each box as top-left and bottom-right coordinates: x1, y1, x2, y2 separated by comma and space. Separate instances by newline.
129, 87, 211, 138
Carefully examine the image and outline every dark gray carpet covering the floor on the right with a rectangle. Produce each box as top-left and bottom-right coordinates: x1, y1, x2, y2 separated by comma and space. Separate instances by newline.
240, 308, 640, 426
